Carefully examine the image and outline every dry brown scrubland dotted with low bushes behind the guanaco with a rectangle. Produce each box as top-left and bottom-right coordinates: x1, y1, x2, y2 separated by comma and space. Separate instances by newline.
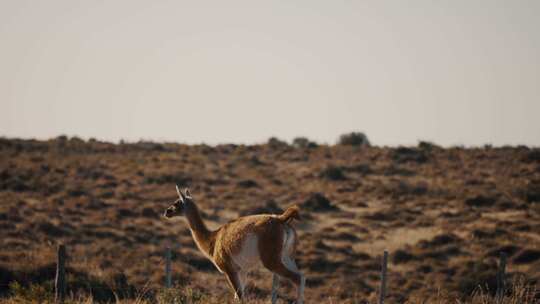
0, 137, 540, 303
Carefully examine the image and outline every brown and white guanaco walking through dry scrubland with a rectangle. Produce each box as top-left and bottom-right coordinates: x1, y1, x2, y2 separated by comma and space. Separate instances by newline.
164, 187, 305, 304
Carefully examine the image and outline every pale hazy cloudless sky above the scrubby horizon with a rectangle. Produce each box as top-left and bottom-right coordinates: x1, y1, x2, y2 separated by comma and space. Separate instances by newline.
0, 0, 540, 146
